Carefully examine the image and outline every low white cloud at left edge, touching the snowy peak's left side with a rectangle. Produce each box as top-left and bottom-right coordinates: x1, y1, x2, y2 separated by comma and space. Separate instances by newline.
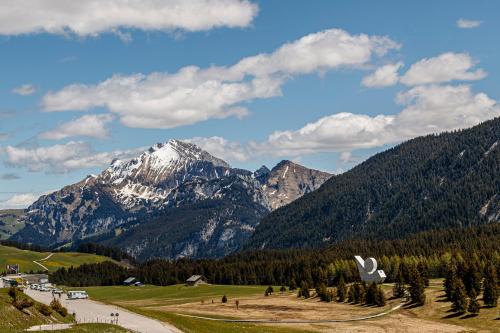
3, 141, 144, 173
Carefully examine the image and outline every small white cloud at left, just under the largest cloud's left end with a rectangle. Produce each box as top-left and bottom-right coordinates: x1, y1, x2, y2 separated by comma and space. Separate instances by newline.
39, 114, 113, 140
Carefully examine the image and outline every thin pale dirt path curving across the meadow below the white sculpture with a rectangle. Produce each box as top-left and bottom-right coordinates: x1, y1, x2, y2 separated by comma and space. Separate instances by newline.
176, 304, 403, 324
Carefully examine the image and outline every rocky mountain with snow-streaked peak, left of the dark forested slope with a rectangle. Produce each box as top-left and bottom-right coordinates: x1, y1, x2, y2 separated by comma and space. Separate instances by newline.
12, 140, 330, 258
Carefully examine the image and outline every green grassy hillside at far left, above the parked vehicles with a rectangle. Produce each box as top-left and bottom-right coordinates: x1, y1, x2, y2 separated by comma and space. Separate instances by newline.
0, 245, 116, 272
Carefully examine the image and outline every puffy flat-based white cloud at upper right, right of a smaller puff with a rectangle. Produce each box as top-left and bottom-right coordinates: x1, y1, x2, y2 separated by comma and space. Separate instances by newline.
400, 52, 486, 86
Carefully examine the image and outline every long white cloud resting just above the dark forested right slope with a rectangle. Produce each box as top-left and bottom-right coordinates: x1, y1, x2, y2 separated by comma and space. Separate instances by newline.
195, 85, 500, 163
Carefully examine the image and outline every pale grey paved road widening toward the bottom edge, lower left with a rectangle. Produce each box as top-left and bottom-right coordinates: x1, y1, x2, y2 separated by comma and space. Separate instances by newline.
26, 289, 182, 333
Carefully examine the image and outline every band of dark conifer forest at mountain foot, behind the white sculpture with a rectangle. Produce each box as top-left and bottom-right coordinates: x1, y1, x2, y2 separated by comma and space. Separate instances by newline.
50, 224, 500, 287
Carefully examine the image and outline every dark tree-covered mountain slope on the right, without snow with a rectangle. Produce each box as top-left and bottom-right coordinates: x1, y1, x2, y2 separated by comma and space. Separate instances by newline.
247, 118, 500, 249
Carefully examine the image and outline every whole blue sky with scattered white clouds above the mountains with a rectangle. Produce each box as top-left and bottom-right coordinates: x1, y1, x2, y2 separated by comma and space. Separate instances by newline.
0, 0, 500, 208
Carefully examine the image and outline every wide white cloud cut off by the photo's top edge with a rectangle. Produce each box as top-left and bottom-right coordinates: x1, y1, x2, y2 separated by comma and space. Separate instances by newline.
0, 0, 259, 37
